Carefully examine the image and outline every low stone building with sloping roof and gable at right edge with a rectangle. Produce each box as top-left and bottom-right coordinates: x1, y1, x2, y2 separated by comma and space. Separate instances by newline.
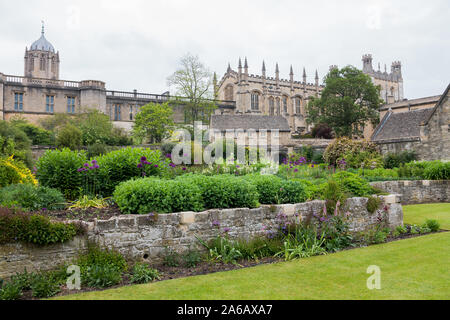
372, 85, 450, 160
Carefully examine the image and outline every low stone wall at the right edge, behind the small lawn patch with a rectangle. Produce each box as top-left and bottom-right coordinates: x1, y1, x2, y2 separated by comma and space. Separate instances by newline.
371, 180, 450, 205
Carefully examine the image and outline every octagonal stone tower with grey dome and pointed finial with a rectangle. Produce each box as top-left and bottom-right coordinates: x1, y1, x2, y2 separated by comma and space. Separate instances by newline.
25, 24, 59, 80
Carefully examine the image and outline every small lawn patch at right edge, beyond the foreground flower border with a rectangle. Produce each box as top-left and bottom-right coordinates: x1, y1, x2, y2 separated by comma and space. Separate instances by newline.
403, 203, 450, 230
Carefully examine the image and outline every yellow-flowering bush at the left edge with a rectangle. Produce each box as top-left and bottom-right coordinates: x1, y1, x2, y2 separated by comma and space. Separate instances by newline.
0, 156, 37, 188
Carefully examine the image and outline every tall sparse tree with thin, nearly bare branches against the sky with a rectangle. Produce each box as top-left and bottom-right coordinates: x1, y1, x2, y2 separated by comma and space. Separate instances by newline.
167, 53, 217, 124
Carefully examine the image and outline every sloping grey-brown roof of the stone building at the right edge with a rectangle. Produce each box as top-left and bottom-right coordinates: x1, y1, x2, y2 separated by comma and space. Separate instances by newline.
372, 108, 433, 142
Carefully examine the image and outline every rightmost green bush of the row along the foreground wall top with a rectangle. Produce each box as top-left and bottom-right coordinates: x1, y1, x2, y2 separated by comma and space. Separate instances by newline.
245, 175, 308, 204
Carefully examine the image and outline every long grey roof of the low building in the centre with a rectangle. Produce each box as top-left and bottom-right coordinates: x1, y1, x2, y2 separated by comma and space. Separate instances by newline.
211, 114, 291, 132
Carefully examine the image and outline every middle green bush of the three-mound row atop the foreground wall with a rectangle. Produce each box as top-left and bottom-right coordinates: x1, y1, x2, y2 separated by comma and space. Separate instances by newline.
175, 174, 259, 209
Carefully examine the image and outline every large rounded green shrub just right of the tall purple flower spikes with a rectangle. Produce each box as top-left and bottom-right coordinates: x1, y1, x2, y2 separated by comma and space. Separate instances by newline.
97, 147, 169, 197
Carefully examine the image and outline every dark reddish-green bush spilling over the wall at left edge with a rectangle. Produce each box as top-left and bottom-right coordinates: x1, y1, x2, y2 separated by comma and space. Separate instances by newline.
0, 208, 84, 245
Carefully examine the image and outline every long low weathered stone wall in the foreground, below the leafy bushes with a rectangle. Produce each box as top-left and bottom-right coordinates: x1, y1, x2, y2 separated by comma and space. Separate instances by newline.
0, 195, 403, 278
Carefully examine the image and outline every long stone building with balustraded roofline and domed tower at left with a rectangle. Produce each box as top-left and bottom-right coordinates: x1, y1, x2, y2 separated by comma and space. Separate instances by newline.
0, 28, 235, 130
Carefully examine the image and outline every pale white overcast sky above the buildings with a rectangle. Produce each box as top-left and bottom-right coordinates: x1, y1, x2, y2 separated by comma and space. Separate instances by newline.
0, 0, 450, 99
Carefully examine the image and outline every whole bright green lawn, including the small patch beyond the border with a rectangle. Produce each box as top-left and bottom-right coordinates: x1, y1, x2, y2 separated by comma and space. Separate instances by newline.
58, 204, 450, 300
